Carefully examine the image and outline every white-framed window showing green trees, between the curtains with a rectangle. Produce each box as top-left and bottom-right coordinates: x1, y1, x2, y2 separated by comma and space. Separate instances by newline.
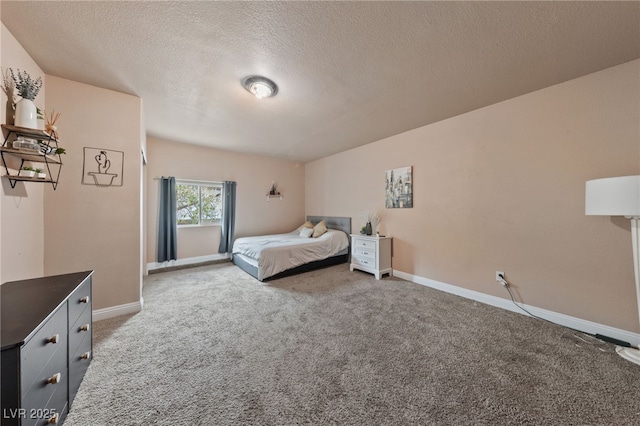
176, 181, 222, 226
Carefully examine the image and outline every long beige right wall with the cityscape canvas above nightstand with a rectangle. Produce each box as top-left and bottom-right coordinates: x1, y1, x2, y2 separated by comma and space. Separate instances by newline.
306, 60, 640, 332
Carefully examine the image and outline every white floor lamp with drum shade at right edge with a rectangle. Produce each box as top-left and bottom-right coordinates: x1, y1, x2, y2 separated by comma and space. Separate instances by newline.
585, 175, 640, 365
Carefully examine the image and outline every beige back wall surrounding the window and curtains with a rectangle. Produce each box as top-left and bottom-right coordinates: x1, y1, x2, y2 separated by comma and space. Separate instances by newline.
146, 137, 304, 263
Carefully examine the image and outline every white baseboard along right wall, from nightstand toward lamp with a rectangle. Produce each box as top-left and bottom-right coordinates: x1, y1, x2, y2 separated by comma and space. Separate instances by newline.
393, 269, 640, 346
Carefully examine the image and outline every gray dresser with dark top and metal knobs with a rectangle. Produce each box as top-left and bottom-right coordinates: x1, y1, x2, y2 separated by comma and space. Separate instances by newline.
0, 271, 93, 425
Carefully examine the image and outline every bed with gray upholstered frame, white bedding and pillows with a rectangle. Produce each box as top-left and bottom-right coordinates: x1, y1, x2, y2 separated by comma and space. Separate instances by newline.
232, 216, 351, 281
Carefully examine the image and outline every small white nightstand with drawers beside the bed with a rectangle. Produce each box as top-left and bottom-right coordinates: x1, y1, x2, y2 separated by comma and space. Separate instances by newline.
350, 234, 393, 280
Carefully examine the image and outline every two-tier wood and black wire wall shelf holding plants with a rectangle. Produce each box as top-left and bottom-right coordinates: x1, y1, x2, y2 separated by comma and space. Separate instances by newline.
0, 124, 62, 190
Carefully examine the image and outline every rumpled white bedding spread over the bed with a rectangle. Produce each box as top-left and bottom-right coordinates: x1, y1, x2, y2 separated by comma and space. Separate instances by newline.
232, 229, 349, 280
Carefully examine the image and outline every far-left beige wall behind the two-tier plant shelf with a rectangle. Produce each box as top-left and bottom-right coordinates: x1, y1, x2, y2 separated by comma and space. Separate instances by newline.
0, 24, 45, 283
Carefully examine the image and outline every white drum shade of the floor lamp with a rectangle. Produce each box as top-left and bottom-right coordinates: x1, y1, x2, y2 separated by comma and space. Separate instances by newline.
584, 175, 640, 217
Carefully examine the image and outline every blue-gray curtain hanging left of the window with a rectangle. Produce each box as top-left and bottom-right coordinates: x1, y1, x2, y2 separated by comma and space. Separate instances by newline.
157, 176, 178, 262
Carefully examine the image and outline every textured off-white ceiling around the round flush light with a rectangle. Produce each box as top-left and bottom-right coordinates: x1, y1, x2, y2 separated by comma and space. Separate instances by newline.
0, 1, 640, 162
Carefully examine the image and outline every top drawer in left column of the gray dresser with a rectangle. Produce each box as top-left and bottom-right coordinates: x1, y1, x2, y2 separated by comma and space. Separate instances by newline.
20, 303, 67, 396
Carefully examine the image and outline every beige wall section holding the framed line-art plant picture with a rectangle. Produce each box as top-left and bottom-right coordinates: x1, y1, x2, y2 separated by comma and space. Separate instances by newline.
45, 75, 143, 309
